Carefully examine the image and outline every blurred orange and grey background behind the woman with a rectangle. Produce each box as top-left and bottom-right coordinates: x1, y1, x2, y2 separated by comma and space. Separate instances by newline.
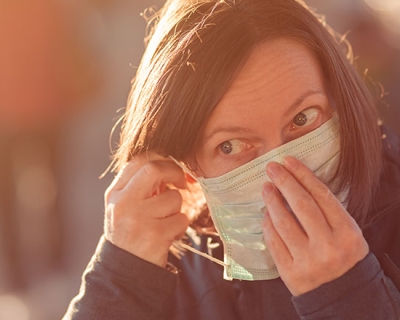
0, 0, 400, 320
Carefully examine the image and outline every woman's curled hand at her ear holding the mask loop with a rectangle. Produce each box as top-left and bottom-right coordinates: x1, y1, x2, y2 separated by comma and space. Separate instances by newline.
104, 153, 189, 267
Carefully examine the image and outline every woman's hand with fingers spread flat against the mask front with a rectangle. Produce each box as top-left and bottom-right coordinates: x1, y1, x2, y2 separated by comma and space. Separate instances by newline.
263, 157, 369, 296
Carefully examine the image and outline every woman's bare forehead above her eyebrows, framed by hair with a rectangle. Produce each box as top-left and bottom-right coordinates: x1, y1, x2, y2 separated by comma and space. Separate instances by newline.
205, 38, 324, 132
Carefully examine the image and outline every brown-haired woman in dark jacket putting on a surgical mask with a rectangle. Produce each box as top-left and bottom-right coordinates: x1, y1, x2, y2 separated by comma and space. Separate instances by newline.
65, 0, 400, 319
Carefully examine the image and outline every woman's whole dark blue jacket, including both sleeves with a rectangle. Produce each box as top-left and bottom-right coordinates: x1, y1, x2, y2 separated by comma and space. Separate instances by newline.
64, 129, 400, 320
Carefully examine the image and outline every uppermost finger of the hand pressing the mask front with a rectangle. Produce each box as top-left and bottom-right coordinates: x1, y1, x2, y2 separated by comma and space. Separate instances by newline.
284, 157, 354, 228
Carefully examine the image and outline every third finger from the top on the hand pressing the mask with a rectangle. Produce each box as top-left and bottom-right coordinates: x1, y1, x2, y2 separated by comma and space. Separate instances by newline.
263, 182, 307, 257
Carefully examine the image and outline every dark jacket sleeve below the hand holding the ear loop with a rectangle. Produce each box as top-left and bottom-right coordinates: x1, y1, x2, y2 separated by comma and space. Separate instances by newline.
63, 237, 177, 320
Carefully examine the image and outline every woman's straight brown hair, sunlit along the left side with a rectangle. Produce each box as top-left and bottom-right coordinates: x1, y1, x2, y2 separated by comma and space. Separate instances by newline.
115, 0, 381, 222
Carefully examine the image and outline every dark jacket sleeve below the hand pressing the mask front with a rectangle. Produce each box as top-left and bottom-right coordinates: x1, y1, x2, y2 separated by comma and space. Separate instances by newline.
292, 253, 400, 320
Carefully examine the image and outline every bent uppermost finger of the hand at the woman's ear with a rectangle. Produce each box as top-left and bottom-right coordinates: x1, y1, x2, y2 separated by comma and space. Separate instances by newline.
125, 160, 187, 199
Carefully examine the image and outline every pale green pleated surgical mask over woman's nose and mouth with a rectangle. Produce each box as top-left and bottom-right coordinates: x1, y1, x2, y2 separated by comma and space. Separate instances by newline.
170, 117, 344, 280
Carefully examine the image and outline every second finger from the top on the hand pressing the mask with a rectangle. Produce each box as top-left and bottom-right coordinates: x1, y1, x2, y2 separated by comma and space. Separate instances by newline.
267, 162, 331, 237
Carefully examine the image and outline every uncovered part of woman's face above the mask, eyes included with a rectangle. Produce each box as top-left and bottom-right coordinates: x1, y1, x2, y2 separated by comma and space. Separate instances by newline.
195, 39, 332, 178
